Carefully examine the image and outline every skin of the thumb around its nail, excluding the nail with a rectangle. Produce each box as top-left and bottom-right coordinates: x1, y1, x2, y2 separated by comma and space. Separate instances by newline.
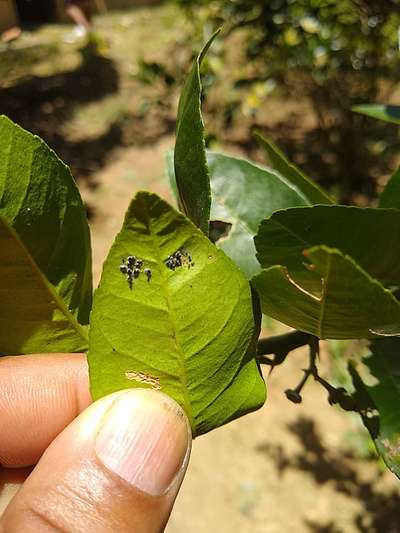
0, 391, 190, 533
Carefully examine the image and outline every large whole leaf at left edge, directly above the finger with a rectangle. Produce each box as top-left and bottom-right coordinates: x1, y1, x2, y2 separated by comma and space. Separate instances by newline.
0, 117, 92, 354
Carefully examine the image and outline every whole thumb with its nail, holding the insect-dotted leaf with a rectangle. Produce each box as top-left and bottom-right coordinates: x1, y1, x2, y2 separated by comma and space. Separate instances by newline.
0, 389, 191, 533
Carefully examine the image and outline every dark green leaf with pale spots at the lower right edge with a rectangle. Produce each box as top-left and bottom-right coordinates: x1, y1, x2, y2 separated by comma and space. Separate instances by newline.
349, 338, 400, 478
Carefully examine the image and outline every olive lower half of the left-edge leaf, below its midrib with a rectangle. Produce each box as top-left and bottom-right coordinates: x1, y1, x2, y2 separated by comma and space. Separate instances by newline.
0, 216, 87, 355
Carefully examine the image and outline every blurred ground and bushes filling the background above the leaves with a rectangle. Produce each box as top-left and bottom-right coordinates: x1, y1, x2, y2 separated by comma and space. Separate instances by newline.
0, 0, 400, 205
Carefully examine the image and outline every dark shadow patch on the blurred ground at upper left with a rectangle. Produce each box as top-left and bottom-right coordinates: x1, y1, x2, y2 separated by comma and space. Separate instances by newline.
0, 49, 121, 182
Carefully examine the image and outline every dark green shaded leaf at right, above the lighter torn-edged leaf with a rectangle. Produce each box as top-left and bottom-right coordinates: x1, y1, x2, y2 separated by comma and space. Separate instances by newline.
254, 205, 400, 286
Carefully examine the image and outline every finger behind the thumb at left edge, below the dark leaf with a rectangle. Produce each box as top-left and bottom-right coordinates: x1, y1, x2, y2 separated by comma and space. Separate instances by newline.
0, 354, 91, 467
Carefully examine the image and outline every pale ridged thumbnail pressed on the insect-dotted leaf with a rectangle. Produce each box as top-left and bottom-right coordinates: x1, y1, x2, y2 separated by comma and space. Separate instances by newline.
95, 389, 191, 496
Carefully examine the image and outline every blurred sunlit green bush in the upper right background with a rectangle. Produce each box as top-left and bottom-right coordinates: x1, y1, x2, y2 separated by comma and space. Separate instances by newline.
176, 0, 400, 89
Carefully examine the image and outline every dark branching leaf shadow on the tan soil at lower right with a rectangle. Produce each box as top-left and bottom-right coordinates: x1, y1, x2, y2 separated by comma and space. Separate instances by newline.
258, 417, 400, 533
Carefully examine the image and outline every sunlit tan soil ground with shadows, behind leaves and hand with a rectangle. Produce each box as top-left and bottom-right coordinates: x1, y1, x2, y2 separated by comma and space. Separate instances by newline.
0, 6, 400, 533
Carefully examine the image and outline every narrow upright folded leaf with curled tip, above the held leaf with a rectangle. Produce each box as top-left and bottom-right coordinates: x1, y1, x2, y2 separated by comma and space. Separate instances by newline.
174, 31, 219, 235
